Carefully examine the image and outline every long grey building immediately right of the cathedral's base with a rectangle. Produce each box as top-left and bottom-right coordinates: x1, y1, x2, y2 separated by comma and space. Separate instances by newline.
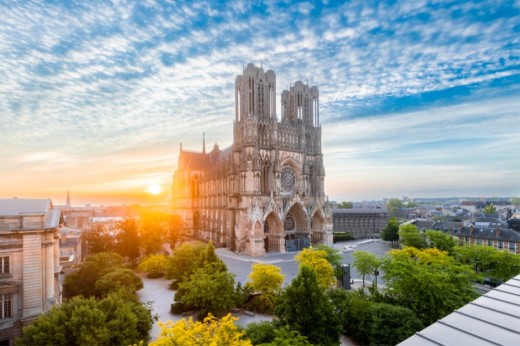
332, 208, 390, 239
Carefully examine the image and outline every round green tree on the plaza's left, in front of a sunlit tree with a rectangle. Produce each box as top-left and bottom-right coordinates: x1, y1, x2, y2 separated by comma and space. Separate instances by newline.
175, 265, 235, 316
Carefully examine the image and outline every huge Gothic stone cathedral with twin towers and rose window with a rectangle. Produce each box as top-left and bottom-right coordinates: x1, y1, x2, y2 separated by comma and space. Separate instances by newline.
172, 64, 332, 256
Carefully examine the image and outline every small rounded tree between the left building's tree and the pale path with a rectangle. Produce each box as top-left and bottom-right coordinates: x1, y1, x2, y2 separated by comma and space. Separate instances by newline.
94, 268, 143, 297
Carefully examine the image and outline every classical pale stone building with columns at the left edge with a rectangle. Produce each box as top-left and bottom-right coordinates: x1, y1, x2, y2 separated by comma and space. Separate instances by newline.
0, 199, 63, 345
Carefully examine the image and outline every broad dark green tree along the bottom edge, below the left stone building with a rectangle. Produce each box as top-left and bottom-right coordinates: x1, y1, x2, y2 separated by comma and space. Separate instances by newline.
16, 294, 152, 346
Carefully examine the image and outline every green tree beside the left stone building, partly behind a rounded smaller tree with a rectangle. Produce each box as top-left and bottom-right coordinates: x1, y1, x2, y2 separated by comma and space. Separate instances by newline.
63, 252, 123, 298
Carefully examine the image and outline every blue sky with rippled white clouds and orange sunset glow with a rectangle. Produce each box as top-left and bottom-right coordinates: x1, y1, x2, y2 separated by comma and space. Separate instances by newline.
0, 0, 520, 206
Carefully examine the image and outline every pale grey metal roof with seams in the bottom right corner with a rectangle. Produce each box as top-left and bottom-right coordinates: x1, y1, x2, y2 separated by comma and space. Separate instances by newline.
399, 275, 520, 346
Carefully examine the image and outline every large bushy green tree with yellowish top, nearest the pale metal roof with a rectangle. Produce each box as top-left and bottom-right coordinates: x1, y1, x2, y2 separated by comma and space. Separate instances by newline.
382, 248, 477, 325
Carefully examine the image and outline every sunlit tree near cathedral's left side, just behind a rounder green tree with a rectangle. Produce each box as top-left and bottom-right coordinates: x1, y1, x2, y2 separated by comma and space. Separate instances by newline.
165, 243, 205, 282
